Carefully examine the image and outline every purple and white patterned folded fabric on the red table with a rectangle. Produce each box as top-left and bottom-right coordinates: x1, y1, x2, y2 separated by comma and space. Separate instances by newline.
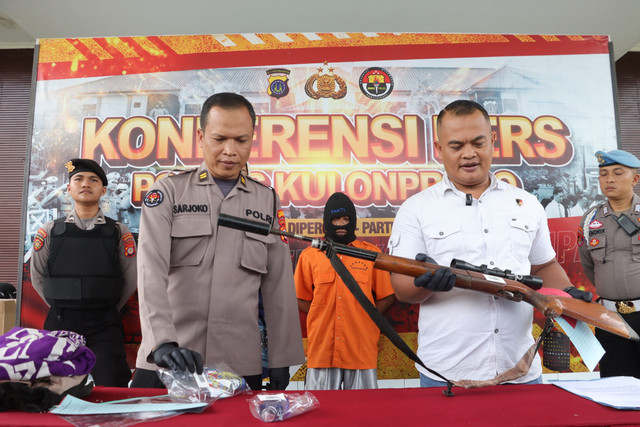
0, 327, 96, 381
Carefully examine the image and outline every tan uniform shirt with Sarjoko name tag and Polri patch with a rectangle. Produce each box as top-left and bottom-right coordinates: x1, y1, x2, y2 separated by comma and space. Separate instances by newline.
136, 163, 304, 375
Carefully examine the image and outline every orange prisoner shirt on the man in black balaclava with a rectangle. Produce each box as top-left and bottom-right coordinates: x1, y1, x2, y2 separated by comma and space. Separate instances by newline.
294, 240, 393, 369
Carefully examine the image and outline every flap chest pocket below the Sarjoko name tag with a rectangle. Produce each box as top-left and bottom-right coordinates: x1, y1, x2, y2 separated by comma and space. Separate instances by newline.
170, 215, 213, 267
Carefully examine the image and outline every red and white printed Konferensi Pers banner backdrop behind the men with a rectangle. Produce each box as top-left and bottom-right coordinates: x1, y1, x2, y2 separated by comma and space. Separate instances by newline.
21, 33, 617, 378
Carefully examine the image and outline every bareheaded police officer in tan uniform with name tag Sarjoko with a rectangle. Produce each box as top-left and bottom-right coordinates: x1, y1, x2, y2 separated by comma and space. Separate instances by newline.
131, 93, 304, 390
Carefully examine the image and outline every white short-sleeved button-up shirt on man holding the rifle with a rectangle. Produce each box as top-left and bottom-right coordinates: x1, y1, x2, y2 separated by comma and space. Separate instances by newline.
389, 174, 555, 383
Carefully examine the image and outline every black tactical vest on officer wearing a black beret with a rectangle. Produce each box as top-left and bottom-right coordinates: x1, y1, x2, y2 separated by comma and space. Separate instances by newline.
43, 217, 123, 308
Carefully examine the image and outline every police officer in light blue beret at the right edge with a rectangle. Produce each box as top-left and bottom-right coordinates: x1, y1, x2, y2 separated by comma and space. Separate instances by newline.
578, 150, 640, 378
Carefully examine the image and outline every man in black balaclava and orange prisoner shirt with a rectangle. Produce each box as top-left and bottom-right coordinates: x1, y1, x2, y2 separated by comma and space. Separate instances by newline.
294, 192, 395, 390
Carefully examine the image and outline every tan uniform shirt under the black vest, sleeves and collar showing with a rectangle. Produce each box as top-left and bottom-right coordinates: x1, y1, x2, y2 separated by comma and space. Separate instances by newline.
31, 210, 137, 310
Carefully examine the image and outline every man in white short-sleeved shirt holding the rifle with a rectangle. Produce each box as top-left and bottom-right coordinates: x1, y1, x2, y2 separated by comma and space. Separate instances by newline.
389, 100, 583, 387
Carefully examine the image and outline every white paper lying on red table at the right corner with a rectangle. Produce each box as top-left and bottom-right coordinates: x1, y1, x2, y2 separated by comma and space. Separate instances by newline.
549, 377, 640, 410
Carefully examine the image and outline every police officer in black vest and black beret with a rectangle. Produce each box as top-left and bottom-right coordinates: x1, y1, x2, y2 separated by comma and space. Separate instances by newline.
31, 159, 136, 387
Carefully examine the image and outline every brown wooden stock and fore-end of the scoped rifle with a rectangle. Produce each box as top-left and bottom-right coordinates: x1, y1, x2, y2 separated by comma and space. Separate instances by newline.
372, 254, 639, 341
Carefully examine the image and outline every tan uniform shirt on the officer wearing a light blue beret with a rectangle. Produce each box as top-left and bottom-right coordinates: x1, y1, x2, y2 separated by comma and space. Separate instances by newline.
578, 194, 640, 300
